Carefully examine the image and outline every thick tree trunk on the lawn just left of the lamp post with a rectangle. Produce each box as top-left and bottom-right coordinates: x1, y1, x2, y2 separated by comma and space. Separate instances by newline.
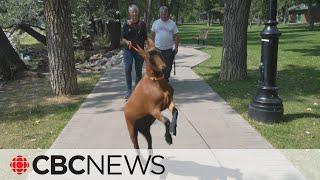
220, 0, 251, 80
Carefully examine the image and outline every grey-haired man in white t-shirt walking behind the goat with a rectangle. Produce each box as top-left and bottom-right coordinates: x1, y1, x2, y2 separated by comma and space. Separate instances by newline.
151, 6, 179, 82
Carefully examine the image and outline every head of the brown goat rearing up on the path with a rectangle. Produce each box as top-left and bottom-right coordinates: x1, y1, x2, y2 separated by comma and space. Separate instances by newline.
135, 39, 166, 72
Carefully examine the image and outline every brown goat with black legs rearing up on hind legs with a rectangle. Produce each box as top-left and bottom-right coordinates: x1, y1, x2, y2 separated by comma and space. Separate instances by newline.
124, 39, 178, 149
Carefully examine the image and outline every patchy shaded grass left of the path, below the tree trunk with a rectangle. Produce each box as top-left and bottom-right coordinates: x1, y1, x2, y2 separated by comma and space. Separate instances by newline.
0, 73, 101, 149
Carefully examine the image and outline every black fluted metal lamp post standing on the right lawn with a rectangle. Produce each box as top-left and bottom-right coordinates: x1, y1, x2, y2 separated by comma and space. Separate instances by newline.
249, 0, 283, 123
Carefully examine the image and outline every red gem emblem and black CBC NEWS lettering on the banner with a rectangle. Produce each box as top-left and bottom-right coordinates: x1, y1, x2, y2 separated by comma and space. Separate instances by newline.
10, 154, 165, 175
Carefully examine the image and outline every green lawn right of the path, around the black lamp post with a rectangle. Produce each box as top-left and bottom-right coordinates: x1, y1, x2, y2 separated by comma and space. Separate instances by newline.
179, 25, 320, 149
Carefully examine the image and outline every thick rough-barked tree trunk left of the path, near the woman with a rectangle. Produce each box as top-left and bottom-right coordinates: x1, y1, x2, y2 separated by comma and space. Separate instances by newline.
44, 0, 78, 95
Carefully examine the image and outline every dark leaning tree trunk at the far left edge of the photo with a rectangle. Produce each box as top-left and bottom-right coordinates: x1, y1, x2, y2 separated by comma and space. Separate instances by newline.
0, 26, 27, 81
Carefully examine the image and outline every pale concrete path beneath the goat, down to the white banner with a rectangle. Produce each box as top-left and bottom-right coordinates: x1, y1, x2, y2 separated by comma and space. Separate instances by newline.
52, 47, 272, 149
